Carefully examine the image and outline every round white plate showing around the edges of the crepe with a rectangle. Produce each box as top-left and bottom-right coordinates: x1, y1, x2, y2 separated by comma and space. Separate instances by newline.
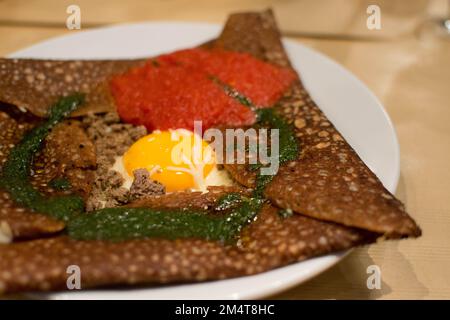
11, 22, 400, 299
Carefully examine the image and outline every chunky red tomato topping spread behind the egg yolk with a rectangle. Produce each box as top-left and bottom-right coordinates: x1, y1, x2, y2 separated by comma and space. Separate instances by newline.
111, 49, 296, 130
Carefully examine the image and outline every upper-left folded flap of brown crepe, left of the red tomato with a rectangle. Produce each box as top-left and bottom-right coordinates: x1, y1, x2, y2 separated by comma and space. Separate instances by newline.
0, 59, 144, 117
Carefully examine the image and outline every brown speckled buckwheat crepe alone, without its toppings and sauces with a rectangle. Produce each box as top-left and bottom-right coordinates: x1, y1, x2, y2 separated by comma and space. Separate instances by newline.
0, 11, 421, 293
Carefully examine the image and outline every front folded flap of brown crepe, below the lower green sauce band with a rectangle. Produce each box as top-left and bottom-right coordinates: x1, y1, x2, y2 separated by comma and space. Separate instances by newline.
0, 199, 374, 292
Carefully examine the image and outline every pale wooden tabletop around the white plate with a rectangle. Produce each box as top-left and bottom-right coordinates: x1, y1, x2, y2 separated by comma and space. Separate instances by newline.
0, 0, 450, 299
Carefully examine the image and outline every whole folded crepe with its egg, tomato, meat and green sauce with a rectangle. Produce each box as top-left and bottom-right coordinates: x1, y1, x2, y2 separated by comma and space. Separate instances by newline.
0, 11, 421, 293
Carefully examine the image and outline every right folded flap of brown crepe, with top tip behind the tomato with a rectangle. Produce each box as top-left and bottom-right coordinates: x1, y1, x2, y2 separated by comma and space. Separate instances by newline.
216, 11, 421, 238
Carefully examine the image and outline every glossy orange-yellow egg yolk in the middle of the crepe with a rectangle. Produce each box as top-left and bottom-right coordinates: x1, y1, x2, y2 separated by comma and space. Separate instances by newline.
123, 129, 215, 192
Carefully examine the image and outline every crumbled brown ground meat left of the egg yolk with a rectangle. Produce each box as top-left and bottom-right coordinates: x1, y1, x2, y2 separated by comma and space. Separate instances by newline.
82, 113, 165, 211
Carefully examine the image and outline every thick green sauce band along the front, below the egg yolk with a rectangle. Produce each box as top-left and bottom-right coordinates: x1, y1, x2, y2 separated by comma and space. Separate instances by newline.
67, 199, 262, 243
